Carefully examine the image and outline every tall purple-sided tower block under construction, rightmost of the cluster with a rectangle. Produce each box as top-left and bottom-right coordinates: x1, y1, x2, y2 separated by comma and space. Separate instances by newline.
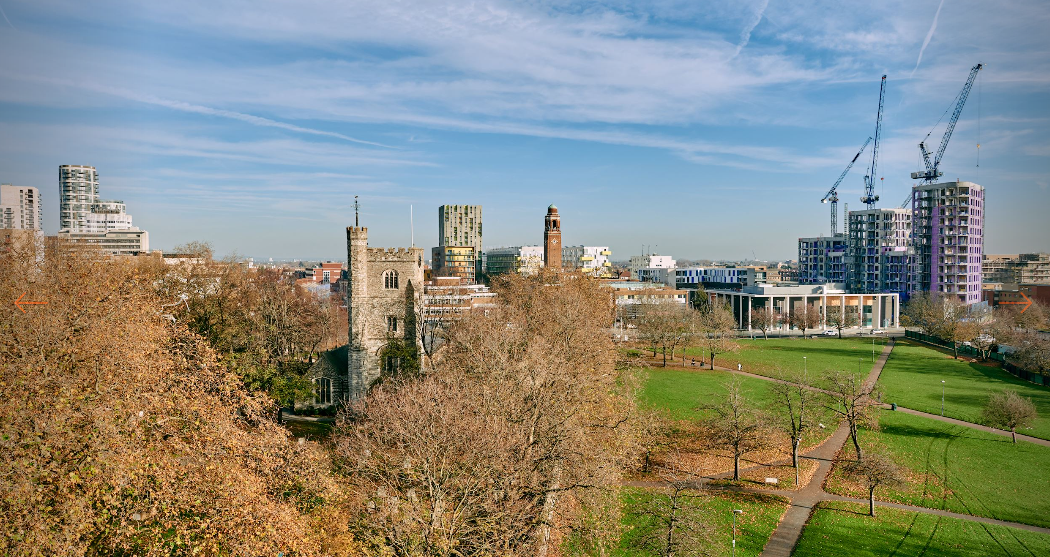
911, 182, 984, 304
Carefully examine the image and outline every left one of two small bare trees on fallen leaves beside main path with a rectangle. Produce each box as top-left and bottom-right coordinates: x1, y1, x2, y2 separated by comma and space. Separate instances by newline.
701, 379, 770, 481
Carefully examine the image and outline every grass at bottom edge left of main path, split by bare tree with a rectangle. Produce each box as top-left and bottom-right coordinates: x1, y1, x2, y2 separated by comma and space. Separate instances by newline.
613, 489, 788, 557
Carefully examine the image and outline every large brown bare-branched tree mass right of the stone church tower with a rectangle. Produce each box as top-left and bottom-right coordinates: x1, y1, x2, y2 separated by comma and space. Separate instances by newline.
335, 272, 642, 556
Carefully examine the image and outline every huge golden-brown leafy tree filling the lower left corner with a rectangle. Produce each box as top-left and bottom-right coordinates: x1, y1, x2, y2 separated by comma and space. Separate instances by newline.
0, 243, 353, 556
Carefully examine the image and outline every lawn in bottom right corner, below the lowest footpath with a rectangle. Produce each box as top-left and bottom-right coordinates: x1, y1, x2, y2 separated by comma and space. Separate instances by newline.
792, 501, 1050, 557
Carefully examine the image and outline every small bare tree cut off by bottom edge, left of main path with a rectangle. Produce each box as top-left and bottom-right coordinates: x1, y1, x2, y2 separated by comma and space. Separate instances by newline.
624, 471, 713, 557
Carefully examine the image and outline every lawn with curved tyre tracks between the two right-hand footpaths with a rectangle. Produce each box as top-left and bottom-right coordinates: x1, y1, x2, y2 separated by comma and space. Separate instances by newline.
826, 410, 1050, 528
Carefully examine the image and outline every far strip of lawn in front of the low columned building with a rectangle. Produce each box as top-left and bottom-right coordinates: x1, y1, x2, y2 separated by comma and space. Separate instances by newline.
672, 336, 886, 381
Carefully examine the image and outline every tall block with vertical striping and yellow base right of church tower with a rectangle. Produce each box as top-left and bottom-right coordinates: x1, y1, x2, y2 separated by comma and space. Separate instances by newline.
431, 205, 482, 283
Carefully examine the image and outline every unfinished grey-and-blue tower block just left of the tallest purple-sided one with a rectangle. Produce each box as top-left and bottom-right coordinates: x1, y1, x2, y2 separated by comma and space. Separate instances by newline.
846, 208, 912, 294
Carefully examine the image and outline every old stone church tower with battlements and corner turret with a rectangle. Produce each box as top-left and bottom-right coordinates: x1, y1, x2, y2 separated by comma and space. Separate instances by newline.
345, 226, 423, 400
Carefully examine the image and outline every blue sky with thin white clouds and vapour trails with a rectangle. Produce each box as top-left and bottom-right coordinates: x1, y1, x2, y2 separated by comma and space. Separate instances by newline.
0, 0, 1050, 261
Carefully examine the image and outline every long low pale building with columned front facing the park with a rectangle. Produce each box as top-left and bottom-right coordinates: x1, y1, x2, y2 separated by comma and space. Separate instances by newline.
708, 285, 901, 330
